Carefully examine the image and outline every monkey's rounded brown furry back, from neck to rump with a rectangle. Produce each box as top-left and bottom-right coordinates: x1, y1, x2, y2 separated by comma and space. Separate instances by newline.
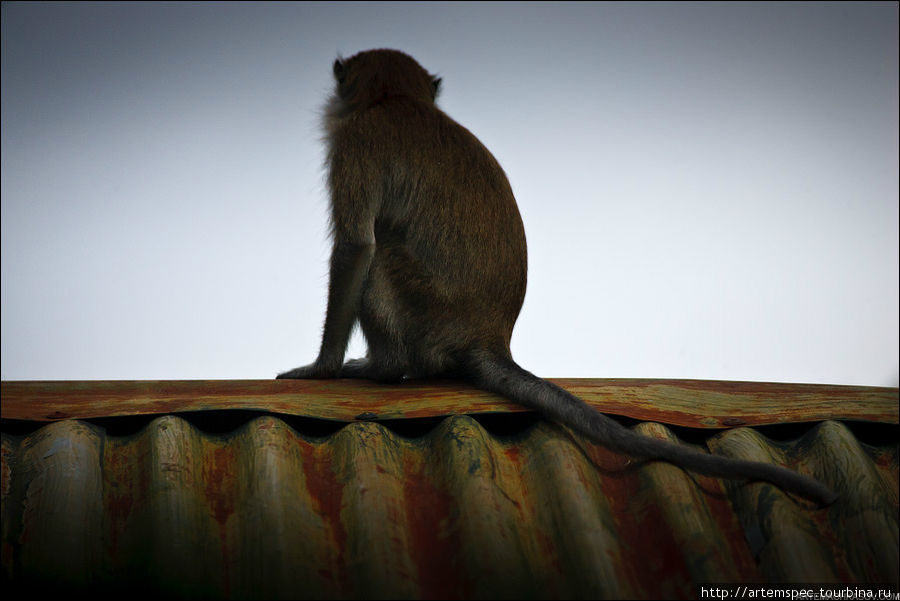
331, 96, 527, 360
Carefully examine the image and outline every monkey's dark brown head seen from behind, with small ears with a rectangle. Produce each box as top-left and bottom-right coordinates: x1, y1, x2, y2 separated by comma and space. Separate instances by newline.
332, 50, 441, 114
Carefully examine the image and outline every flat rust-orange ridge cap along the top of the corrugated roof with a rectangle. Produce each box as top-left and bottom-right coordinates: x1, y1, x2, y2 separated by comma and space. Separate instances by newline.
0, 378, 900, 428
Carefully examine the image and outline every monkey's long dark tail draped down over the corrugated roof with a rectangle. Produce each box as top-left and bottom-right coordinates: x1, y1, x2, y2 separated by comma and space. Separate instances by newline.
467, 351, 838, 505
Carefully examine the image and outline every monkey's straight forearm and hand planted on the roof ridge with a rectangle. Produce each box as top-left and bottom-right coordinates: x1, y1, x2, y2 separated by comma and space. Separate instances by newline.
278, 239, 375, 379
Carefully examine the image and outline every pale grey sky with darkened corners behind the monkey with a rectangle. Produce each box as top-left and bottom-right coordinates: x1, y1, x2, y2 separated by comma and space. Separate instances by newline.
2, 2, 900, 386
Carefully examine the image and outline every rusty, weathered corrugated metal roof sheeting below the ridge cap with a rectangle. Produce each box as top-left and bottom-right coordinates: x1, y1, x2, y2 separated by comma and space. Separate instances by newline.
2, 383, 900, 598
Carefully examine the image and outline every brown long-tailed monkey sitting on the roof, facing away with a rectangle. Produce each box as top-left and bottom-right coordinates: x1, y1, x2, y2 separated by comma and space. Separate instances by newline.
277, 49, 837, 505
